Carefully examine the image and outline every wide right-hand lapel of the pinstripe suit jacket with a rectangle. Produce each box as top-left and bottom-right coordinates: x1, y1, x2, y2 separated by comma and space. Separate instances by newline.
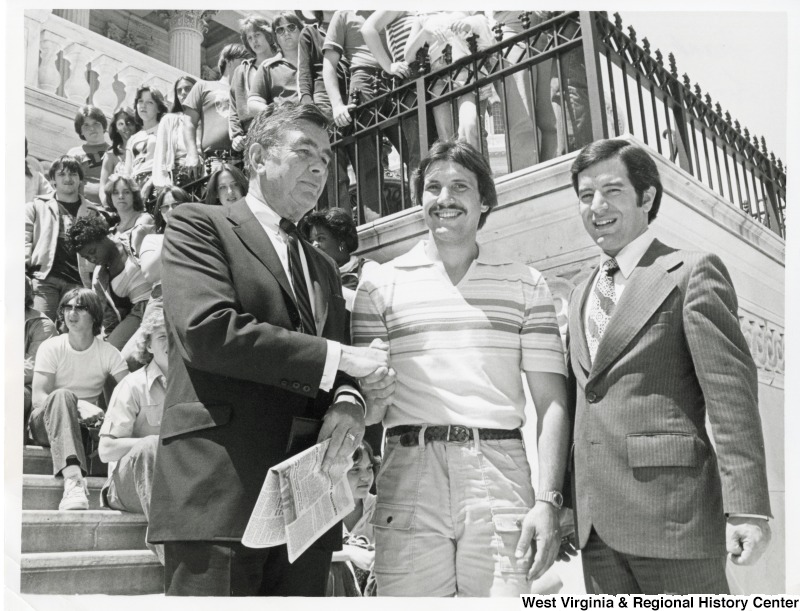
589, 240, 677, 378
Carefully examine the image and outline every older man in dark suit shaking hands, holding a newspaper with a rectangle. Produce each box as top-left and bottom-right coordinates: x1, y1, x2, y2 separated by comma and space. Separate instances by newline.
149, 106, 387, 596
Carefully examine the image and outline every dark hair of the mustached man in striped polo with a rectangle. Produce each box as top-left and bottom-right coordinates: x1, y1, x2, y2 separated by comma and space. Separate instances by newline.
413, 140, 497, 229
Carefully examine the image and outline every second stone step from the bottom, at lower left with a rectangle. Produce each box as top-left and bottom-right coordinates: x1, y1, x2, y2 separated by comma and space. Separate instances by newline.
22, 509, 147, 554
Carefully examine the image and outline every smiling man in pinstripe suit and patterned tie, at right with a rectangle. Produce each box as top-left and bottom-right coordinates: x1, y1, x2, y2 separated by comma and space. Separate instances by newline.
569, 140, 770, 594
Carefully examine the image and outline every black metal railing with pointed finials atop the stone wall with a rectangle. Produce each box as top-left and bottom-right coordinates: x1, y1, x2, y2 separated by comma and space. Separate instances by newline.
332, 11, 786, 237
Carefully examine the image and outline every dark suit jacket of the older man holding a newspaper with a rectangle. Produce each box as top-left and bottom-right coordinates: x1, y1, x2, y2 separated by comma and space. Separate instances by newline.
149, 200, 352, 549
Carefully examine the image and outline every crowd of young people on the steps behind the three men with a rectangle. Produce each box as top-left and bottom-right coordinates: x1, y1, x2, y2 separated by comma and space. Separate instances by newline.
23, 11, 590, 595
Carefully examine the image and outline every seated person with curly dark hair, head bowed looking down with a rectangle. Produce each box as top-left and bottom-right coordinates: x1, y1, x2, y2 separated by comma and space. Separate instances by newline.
69, 216, 152, 350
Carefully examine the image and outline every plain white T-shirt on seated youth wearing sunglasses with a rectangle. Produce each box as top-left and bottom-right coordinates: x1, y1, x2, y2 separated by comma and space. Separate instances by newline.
33, 333, 128, 403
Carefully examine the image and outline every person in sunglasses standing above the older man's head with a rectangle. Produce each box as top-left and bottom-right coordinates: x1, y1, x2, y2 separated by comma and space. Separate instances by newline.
247, 11, 303, 116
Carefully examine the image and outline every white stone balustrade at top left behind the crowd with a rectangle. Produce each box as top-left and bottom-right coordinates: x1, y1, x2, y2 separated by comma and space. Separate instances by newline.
25, 10, 185, 116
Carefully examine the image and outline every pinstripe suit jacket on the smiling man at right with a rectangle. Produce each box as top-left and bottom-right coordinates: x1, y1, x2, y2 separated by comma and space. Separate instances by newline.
569, 240, 770, 558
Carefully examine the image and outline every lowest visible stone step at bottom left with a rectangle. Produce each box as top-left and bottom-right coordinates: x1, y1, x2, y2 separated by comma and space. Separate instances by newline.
20, 550, 164, 595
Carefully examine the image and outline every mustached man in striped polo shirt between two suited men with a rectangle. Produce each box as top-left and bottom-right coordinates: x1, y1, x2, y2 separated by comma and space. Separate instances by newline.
352, 141, 569, 596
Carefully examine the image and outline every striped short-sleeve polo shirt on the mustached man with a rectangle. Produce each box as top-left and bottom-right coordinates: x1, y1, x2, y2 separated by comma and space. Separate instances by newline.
352, 241, 566, 429
